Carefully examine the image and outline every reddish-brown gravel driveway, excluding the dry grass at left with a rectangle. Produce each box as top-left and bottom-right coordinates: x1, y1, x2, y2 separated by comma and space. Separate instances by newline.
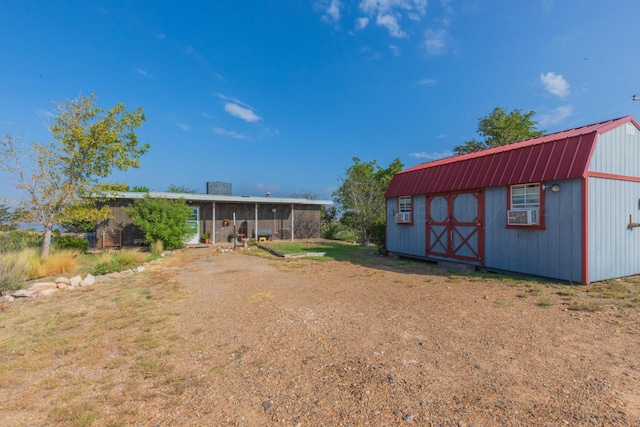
148, 249, 640, 426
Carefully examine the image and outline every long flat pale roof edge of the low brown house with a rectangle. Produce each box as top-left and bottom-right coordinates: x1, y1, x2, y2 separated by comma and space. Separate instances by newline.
109, 191, 333, 205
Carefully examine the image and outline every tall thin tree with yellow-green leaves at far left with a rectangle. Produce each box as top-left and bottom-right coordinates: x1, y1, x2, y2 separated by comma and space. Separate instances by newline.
0, 95, 149, 258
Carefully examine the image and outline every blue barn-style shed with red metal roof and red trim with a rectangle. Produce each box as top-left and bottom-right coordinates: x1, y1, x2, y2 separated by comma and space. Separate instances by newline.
385, 116, 640, 284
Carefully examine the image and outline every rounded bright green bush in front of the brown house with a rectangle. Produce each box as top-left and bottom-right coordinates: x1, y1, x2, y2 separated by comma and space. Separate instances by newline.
125, 195, 191, 249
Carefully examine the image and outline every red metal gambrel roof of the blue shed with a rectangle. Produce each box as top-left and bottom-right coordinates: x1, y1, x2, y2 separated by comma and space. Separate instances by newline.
385, 116, 640, 197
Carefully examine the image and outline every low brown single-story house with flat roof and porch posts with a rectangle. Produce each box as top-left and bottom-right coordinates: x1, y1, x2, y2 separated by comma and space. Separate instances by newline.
96, 191, 333, 248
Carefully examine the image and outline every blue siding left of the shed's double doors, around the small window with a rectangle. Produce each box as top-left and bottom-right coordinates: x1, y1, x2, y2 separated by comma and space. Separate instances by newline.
387, 196, 427, 258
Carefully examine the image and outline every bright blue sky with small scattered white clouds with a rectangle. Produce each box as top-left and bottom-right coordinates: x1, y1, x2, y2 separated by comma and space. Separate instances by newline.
0, 0, 640, 204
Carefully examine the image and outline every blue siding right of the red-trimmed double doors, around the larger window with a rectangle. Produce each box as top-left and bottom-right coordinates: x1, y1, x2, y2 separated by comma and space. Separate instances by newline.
485, 179, 582, 282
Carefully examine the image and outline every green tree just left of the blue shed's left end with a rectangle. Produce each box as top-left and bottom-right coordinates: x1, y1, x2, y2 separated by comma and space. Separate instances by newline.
333, 157, 403, 245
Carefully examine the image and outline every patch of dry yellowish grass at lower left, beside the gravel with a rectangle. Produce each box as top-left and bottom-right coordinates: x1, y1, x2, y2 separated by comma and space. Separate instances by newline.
0, 255, 190, 427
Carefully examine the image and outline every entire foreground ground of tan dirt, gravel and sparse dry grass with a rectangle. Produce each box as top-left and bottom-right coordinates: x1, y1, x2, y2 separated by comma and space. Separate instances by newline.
0, 249, 640, 427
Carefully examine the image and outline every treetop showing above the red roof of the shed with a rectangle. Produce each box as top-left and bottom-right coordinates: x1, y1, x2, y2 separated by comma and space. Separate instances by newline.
453, 107, 545, 155
